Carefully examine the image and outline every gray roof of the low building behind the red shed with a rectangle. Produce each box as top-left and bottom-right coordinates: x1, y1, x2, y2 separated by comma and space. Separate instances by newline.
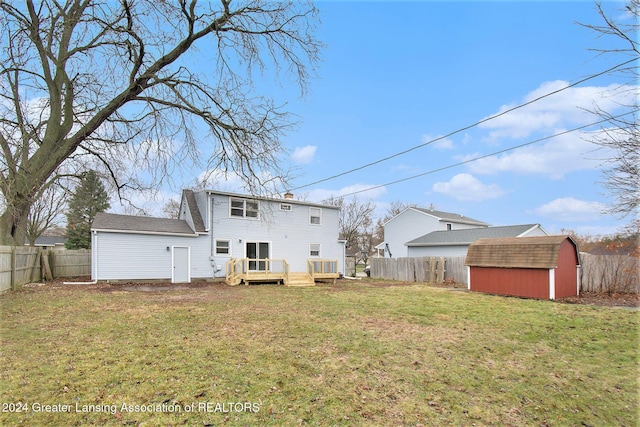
405, 224, 546, 246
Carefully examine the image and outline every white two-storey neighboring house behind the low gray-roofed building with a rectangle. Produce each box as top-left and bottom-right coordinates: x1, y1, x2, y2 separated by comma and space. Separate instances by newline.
376, 207, 489, 258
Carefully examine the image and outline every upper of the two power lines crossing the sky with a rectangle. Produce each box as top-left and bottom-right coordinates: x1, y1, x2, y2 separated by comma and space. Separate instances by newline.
288, 58, 636, 191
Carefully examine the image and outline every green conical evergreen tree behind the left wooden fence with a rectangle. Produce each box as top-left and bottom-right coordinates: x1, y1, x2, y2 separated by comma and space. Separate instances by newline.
65, 170, 110, 249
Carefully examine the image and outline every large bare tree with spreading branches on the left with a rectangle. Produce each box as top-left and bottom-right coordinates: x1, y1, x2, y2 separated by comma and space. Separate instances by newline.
0, 0, 321, 244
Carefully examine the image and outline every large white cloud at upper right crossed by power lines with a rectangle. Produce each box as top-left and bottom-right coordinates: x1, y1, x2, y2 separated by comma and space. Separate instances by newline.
479, 80, 640, 141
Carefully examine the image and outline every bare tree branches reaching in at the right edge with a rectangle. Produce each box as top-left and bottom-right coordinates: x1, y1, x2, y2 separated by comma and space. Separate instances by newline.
582, 0, 640, 224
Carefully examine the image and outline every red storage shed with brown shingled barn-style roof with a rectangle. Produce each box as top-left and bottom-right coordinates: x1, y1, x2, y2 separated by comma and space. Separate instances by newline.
465, 236, 580, 299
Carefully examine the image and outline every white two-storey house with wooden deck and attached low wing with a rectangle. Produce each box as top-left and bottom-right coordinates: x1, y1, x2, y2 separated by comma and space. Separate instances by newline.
91, 190, 345, 284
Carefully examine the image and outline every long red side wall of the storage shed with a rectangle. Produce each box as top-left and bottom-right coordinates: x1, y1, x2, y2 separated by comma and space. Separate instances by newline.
470, 265, 552, 299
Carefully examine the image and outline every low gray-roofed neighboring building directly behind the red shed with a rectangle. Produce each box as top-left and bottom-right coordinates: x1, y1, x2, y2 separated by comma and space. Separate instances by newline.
406, 224, 549, 257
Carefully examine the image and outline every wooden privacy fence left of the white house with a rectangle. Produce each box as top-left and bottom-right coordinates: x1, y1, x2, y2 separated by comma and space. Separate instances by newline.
0, 246, 91, 292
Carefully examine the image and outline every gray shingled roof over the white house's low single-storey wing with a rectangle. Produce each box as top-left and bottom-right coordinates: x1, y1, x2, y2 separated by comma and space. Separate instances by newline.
91, 212, 195, 236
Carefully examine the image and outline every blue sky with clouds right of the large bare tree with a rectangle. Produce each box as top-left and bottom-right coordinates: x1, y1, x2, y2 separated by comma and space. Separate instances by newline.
136, 1, 632, 234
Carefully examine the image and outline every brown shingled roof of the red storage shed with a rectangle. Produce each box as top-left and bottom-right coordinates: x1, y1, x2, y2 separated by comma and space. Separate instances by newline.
464, 236, 580, 268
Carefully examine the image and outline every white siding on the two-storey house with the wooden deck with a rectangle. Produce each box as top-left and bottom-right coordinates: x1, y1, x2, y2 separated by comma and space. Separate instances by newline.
91, 192, 344, 280
